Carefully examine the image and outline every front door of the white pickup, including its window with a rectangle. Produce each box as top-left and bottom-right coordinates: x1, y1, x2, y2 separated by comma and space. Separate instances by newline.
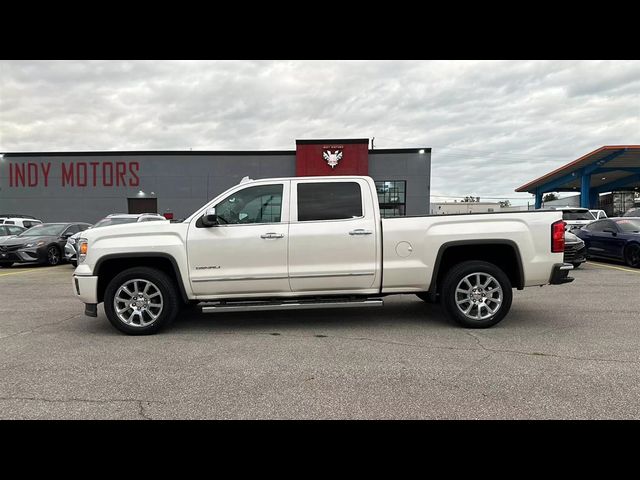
187, 181, 291, 297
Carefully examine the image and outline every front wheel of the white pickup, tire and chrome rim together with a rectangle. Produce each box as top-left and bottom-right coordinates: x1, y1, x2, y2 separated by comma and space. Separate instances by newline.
104, 267, 180, 335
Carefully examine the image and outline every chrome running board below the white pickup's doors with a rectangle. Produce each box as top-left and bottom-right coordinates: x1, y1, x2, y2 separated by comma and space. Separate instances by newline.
202, 298, 384, 313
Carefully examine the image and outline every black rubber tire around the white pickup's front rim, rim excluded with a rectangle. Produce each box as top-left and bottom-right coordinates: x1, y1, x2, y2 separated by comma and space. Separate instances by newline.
104, 267, 182, 335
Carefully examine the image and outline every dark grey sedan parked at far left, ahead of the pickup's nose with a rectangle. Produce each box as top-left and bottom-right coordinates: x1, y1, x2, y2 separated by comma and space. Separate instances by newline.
0, 223, 91, 267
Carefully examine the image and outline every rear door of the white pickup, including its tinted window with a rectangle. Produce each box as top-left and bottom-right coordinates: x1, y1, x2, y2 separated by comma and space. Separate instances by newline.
289, 178, 377, 294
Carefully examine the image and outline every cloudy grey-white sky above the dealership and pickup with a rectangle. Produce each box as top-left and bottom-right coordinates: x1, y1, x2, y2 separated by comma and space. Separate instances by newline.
0, 61, 640, 204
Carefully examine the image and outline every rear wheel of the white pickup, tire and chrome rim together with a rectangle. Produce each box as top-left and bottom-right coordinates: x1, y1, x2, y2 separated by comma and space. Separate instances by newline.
441, 260, 513, 328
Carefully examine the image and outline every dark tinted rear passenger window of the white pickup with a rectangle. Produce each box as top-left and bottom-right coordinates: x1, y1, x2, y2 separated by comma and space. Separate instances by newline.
298, 182, 362, 222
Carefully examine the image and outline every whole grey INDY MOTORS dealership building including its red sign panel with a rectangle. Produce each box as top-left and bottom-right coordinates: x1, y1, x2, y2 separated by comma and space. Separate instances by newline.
0, 138, 431, 223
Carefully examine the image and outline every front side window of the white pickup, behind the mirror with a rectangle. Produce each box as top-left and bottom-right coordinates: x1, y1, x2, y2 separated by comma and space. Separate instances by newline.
216, 185, 283, 225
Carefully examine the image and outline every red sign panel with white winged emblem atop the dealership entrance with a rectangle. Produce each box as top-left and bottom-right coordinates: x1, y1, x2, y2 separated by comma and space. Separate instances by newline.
296, 138, 369, 177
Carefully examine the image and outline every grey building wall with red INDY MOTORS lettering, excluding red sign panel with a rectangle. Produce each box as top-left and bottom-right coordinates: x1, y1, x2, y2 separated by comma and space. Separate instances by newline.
0, 151, 431, 223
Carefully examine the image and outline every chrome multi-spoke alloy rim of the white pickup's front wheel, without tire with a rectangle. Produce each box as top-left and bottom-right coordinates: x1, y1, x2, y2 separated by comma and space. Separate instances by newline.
113, 278, 163, 327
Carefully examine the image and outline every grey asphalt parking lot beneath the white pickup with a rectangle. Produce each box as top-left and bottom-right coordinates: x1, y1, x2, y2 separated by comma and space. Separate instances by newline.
0, 262, 640, 419
